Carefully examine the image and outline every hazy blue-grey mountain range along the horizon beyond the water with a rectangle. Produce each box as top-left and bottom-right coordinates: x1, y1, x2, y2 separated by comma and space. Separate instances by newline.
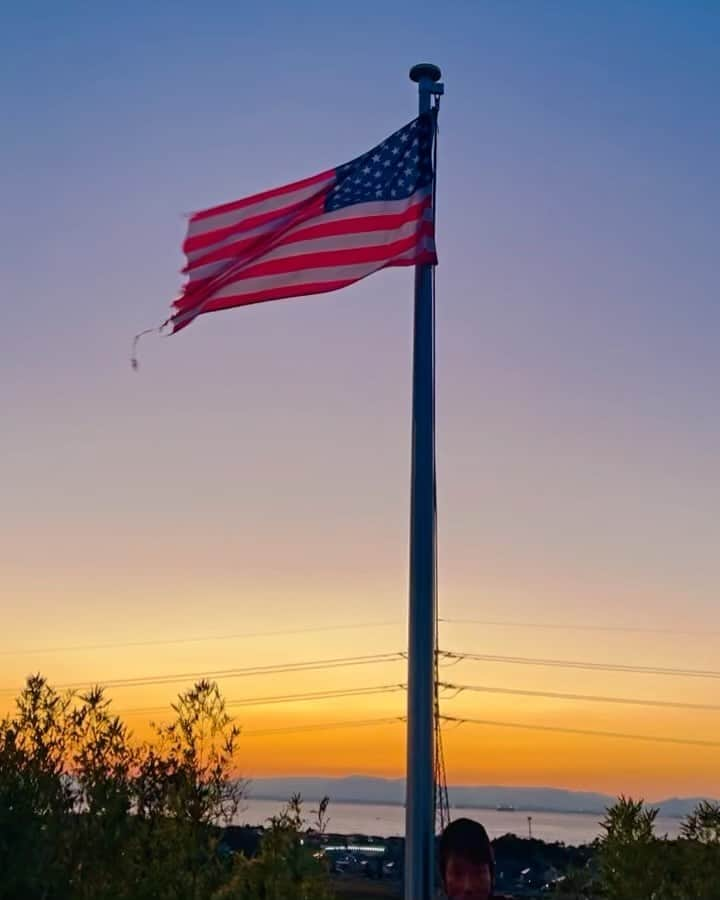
248, 775, 709, 817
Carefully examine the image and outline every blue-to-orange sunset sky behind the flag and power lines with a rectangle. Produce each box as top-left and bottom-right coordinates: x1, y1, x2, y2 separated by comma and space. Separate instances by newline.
0, 0, 720, 799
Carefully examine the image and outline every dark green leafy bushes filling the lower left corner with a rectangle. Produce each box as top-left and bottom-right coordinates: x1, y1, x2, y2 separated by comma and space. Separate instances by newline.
0, 675, 327, 900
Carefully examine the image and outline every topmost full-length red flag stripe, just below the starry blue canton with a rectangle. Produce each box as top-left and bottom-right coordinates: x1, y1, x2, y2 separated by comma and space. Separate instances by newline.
183, 197, 432, 273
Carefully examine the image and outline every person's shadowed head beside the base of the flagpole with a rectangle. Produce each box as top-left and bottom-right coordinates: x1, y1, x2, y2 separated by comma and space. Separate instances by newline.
440, 819, 495, 900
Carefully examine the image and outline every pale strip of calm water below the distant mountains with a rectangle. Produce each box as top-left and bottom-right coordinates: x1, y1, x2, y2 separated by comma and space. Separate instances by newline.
235, 797, 680, 845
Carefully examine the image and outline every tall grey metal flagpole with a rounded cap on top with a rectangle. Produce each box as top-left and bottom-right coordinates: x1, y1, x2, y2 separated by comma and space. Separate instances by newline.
405, 63, 442, 900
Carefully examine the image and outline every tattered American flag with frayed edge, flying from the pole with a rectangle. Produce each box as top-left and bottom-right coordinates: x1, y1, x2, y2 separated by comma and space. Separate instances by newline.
169, 111, 437, 332
